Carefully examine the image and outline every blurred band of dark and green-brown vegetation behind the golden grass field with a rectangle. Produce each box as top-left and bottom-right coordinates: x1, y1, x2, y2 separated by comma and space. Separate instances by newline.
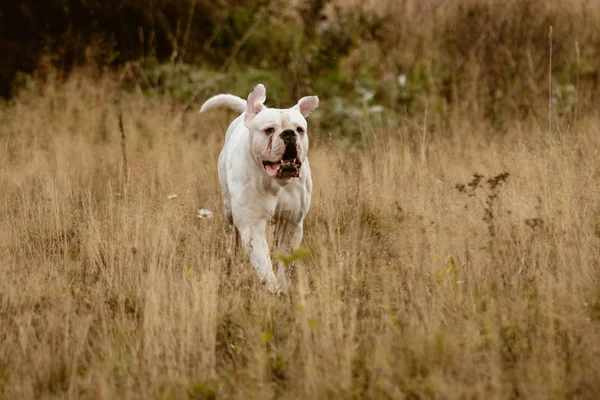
0, 0, 600, 134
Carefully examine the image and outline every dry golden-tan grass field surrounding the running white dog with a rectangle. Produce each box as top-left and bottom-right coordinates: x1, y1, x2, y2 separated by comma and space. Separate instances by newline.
0, 72, 600, 399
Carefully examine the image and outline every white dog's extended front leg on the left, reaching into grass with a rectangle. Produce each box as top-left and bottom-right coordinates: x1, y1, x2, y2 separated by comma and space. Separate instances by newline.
238, 221, 279, 293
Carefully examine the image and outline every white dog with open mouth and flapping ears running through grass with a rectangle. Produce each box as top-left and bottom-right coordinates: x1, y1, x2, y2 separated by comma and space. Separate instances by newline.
200, 84, 319, 292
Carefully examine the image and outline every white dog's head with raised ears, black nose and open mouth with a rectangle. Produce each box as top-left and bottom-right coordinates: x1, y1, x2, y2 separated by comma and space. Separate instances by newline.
244, 84, 319, 179
